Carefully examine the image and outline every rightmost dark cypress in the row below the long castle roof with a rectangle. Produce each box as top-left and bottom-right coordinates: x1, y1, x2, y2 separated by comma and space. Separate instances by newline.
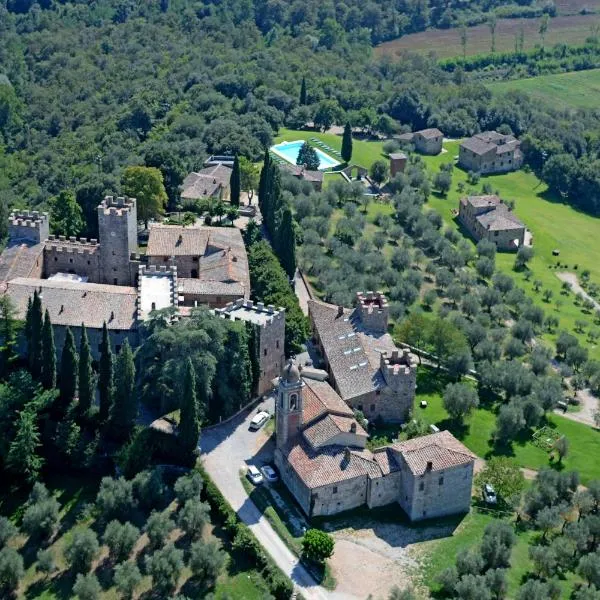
110, 340, 138, 439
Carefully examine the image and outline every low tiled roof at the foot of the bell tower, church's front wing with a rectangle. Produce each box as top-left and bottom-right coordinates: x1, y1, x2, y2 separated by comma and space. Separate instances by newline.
283, 439, 382, 488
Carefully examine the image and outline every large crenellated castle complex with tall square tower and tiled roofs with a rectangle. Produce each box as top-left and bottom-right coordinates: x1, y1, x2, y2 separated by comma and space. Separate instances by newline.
0, 196, 250, 358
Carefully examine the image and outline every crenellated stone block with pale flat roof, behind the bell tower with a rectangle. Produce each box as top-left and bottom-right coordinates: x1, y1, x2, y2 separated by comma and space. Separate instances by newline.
215, 299, 285, 395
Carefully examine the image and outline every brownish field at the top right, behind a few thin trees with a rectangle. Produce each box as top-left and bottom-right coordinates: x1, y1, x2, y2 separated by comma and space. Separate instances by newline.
375, 14, 599, 59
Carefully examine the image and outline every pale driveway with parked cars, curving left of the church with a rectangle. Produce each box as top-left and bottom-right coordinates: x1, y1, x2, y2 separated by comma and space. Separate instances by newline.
200, 398, 336, 600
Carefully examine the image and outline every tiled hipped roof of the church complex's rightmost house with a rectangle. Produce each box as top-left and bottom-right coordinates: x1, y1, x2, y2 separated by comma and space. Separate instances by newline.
391, 431, 477, 476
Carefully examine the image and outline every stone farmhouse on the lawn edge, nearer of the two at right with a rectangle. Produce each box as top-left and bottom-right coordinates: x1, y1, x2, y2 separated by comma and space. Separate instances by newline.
458, 195, 526, 251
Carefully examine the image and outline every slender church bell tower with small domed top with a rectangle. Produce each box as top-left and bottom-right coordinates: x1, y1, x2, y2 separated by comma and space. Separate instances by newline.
275, 359, 304, 448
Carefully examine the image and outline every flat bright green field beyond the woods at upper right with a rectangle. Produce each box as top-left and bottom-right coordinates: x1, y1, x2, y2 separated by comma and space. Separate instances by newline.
488, 69, 600, 109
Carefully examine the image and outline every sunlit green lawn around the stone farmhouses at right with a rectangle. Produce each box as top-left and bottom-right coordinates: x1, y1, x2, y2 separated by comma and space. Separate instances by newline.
424, 142, 600, 359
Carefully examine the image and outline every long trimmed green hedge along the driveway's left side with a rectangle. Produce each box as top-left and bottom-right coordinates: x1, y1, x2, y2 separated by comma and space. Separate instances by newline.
196, 465, 294, 600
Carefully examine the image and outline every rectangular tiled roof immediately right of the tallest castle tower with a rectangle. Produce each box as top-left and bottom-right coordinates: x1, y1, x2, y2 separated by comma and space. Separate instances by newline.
146, 223, 210, 256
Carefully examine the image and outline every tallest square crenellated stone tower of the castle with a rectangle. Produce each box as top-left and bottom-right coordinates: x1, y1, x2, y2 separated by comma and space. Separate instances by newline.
98, 196, 138, 285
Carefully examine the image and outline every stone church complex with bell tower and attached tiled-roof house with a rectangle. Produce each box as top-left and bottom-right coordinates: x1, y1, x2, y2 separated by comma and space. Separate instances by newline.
275, 362, 476, 521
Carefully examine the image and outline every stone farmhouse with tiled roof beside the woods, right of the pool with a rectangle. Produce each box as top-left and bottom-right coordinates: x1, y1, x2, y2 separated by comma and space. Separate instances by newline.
458, 131, 523, 175
